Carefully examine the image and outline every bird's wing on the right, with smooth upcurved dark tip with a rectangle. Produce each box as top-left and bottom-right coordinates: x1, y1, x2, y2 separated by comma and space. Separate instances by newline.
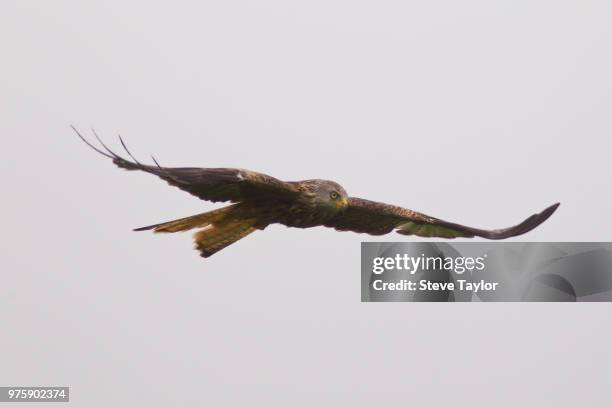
325, 197, 559, 239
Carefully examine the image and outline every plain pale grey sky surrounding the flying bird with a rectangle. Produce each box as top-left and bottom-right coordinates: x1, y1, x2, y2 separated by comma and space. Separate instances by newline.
0, 0, 612, 407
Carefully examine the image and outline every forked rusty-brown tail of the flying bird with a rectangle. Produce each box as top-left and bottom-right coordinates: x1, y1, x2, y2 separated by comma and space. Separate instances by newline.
134, 204, 257, 258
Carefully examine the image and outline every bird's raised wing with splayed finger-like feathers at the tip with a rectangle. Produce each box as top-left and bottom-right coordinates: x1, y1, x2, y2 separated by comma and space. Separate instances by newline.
72, 126, 299, 202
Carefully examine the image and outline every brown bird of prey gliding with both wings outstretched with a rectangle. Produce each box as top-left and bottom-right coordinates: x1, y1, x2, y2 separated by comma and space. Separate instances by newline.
72, 127, 559, 258
